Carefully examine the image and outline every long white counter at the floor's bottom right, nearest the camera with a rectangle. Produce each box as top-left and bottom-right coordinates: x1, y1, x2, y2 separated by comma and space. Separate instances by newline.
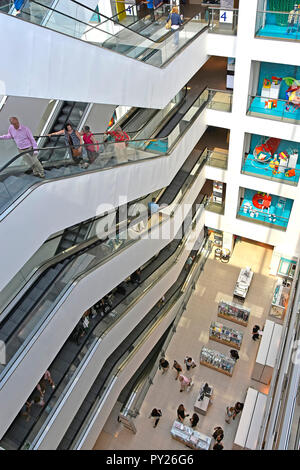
232, 388, 267, 450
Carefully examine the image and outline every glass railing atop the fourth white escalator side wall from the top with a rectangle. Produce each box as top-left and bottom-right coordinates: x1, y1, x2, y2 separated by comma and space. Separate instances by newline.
18, 205, 203, 448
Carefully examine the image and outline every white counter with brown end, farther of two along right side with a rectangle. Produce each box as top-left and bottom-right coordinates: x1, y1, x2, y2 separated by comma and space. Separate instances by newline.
252, 320, 282, 385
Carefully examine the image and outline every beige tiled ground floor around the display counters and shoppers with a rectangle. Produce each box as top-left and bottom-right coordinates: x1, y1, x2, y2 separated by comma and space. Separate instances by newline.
94, 242, 275, 450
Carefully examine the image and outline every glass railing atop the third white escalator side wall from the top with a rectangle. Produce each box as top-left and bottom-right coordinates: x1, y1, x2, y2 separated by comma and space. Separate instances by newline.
0, 143, 207, 396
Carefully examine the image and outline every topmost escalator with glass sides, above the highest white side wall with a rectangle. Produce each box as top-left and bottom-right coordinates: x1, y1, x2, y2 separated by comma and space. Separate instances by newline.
0, 0, 207, 67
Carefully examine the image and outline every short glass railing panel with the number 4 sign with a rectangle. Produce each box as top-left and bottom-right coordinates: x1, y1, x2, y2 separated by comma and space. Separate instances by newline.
205, 7, 239, 36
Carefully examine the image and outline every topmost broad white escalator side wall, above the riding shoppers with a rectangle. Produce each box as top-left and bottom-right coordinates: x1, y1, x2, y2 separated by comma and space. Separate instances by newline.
0, 15, 208, 108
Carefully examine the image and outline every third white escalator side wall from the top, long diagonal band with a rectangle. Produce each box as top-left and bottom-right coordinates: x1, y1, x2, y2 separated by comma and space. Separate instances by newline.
0, 165, 205, 438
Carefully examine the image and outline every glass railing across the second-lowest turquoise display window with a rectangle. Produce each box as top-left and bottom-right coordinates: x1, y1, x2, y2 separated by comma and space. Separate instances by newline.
241, 154, 300, 186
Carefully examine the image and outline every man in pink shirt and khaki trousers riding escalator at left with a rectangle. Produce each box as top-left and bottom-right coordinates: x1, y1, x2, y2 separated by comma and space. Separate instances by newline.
0, 117, 45, 178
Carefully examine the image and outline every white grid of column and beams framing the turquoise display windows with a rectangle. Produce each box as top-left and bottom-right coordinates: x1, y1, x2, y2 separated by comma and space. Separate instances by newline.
205, 0, 300, 254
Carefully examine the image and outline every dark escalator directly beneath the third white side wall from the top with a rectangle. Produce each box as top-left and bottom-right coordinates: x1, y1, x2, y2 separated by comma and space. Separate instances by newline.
0, 186, 203, 449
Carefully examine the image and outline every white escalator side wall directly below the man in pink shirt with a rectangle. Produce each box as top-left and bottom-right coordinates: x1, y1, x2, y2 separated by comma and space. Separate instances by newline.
0, 108, 206, 289
